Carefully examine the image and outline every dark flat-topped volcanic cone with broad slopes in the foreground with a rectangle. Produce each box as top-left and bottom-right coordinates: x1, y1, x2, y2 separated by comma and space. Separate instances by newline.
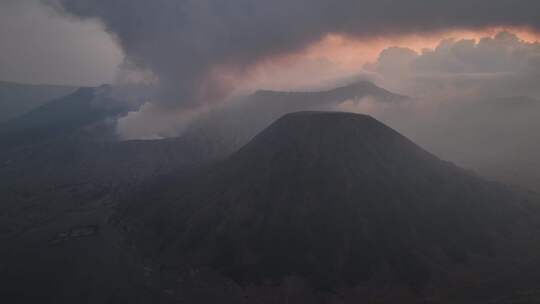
113, 112, 540, 303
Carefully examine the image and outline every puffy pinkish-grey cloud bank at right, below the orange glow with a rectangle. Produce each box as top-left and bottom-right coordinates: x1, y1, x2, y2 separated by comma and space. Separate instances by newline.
365, 32, 540, 100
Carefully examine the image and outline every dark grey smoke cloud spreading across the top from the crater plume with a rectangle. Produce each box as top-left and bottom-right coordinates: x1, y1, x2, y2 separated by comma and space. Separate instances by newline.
47, 0, 540, 105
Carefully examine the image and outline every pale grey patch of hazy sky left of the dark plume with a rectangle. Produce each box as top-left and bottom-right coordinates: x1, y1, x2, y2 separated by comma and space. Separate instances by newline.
0, 0, 122, 85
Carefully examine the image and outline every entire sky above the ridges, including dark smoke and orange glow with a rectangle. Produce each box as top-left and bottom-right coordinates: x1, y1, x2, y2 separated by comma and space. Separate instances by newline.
0, 0, 540, 91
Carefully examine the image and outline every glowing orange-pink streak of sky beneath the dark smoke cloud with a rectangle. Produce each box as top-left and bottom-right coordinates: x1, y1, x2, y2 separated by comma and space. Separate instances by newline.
239, 27, 540, 92
